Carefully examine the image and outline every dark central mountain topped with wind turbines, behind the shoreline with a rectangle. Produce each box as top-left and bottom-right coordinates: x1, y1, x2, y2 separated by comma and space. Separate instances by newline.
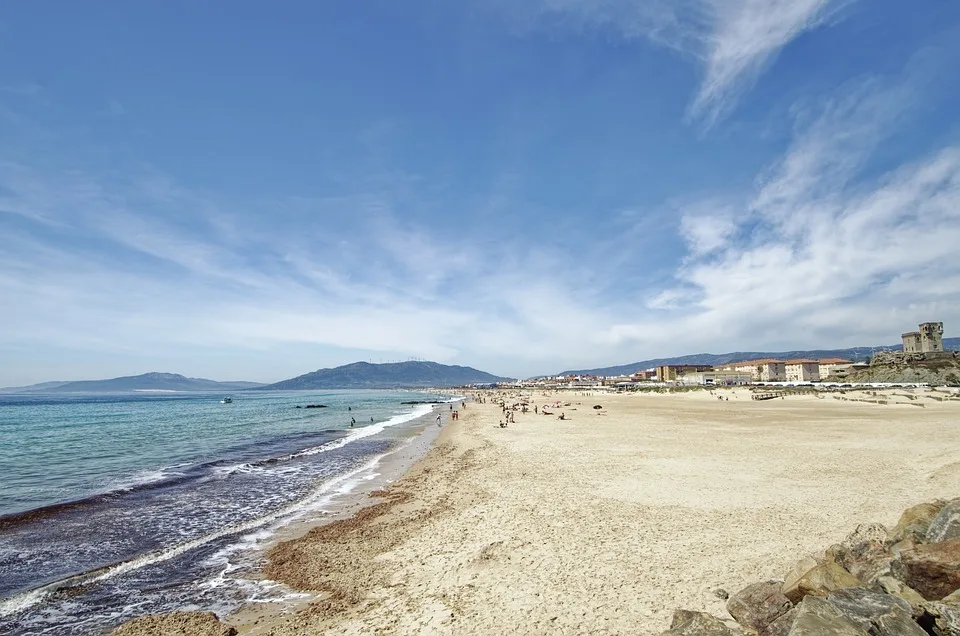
260, 362, 509, 390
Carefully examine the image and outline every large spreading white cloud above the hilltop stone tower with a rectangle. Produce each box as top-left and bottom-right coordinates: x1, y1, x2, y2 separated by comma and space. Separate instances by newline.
607, 67, 960, 356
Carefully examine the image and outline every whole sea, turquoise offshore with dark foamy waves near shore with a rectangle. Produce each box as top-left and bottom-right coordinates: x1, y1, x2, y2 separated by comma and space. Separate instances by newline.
0, 391, 455, 635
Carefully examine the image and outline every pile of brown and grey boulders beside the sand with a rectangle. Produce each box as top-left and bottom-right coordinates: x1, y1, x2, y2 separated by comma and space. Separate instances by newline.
661, 499, 960, 636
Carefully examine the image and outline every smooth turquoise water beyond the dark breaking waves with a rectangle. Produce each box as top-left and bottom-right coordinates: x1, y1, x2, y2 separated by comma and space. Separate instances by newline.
0, 391, 422, 515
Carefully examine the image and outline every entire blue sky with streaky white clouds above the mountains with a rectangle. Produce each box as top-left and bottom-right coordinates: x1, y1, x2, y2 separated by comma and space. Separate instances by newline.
0, 0, 960, 386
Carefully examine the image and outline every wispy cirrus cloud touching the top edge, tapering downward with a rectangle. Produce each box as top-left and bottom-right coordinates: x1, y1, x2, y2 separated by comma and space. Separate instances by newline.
495, 0, 855, 128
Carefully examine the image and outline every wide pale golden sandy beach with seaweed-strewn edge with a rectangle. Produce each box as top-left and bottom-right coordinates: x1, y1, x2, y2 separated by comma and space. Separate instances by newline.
227, 389, 960, 636
